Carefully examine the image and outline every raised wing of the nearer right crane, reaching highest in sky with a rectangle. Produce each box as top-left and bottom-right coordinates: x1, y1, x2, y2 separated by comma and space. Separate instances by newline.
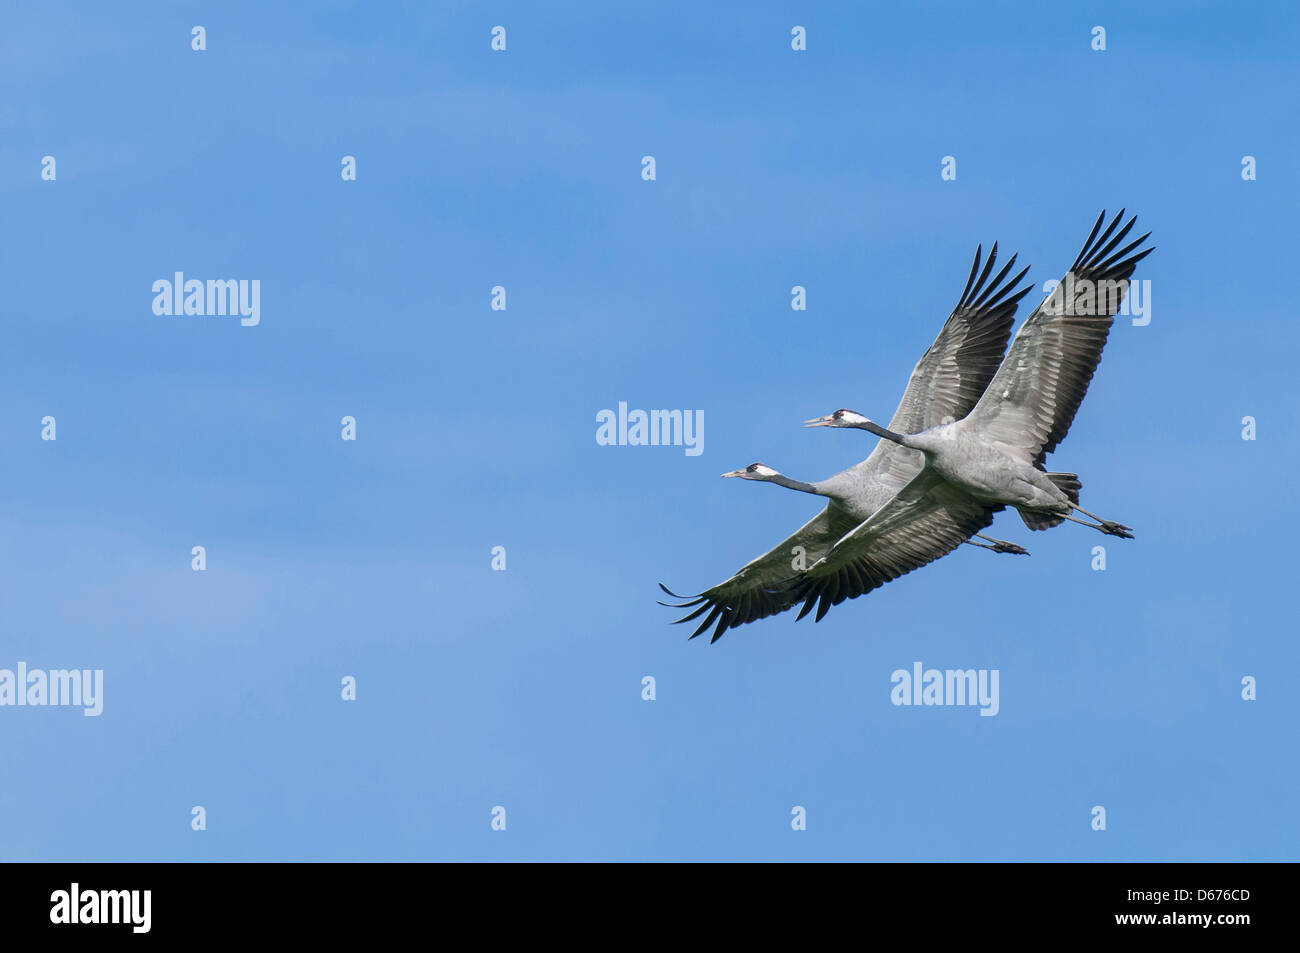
970, 209, 1154, 467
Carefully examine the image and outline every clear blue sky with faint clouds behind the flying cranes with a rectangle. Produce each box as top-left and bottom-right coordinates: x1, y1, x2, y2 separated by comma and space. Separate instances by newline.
0, 3, 1300, 861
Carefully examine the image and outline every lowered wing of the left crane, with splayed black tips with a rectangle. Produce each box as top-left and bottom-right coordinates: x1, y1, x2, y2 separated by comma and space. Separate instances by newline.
659, 503, 858, 642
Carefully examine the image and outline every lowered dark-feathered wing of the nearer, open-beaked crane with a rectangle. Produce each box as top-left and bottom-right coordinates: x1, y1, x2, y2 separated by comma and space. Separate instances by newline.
792, 468, 1002, 621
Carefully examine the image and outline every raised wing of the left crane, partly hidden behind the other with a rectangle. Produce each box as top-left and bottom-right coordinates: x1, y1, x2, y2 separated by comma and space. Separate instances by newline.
854, 242, 1034, 501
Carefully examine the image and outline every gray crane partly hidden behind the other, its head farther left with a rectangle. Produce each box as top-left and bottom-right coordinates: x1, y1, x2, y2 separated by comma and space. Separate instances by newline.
659, 243, 1032, 642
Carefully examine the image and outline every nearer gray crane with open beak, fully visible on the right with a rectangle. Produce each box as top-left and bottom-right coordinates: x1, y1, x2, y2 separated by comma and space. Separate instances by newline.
792, 209, 1154, 620
